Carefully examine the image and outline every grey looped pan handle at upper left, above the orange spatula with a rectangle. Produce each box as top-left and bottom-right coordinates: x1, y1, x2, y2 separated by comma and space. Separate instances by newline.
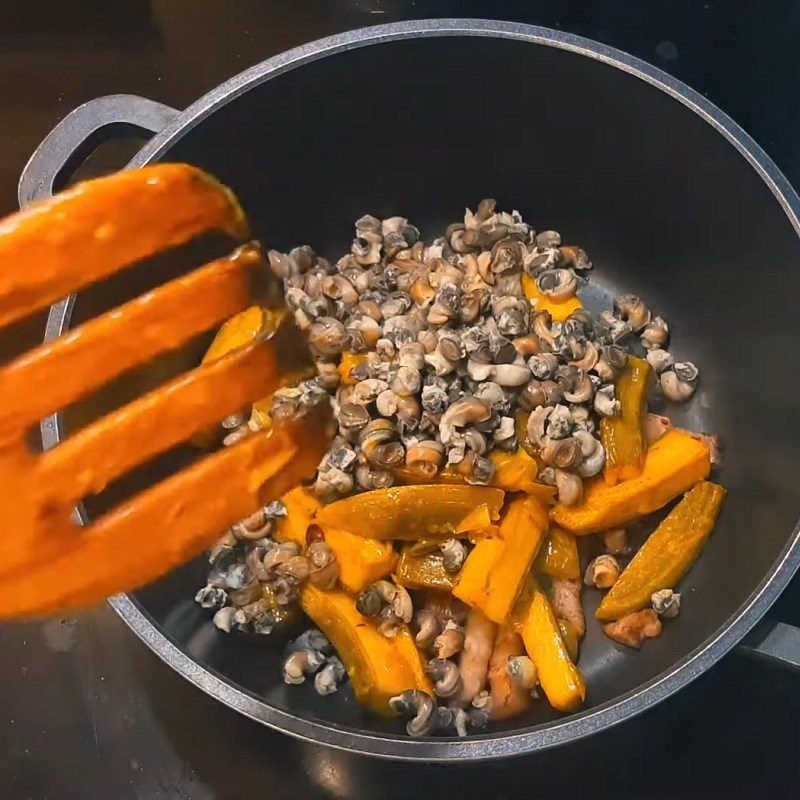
17, 94, 180, 208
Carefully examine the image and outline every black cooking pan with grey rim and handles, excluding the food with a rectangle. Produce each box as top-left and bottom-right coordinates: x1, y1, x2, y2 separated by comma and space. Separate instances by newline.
20, 20, 800, 761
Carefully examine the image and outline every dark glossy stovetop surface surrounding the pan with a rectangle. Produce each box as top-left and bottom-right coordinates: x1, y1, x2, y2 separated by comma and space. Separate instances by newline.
0, 0, 800, 800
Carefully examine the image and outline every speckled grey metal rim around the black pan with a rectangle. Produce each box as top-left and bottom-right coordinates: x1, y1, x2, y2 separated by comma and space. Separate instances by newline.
42, 19, 800, 762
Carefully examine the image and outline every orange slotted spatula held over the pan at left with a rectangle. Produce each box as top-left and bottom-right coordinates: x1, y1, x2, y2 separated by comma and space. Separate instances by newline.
0, 164, 323, 618
